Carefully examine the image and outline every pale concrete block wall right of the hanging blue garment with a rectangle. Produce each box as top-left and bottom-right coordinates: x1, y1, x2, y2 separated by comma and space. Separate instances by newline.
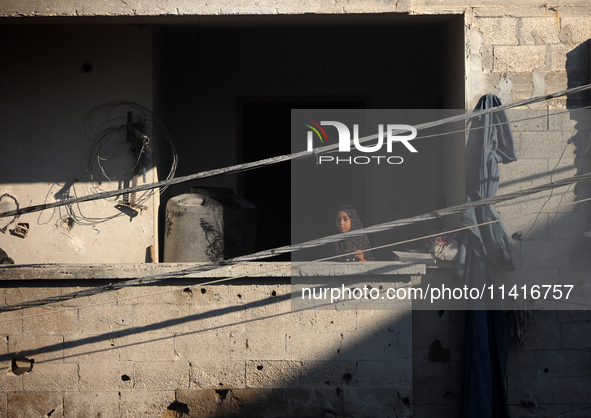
474, 8, 591, 417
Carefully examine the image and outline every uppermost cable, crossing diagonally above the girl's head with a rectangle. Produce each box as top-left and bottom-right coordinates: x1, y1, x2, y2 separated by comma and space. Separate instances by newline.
0, 84, 591, 218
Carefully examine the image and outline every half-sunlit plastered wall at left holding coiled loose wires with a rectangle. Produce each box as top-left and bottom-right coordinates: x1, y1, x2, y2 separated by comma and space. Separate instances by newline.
0, 26, 157, 264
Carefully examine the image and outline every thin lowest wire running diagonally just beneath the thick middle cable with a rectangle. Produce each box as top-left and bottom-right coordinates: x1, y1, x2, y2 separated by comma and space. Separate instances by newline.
0, 189, 591, 323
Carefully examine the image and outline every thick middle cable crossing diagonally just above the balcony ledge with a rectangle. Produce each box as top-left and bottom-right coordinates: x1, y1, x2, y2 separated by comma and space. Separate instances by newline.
0, 173, 591, 312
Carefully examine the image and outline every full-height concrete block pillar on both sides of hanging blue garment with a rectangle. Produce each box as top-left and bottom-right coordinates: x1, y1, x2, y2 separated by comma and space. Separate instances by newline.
413, 6, 591, 417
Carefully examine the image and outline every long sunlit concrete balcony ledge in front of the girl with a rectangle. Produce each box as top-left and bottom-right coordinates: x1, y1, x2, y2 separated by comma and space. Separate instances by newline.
0, 261, 426, 281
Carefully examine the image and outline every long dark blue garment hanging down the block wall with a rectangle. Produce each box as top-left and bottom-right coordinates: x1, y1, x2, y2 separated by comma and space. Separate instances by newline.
458, 94, 517, 418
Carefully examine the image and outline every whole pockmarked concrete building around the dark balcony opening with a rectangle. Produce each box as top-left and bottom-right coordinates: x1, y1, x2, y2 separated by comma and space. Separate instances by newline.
0, 0, 591, 418
